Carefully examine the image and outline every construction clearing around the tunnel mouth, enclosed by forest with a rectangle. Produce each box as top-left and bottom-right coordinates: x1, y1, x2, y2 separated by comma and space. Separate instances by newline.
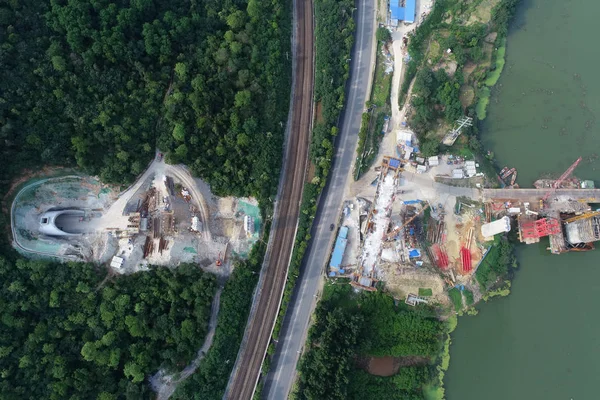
11, 155, 261, 275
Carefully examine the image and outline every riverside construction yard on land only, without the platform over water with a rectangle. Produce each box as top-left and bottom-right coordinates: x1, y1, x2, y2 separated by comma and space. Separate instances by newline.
329, 156, 490, 305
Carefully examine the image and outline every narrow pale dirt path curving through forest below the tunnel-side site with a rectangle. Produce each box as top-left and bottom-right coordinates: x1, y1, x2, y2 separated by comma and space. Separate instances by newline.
150, 287, 223, 400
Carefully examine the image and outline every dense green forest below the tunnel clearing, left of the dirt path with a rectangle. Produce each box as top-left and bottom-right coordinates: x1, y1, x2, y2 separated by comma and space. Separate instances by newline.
0, 258, 216, 400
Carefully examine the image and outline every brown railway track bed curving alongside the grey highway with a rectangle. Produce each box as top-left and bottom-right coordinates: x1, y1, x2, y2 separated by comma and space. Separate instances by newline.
224, 0, 314, 400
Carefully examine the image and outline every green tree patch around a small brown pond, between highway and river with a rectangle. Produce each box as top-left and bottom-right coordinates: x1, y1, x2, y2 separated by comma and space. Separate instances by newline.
296, 281, 444, 400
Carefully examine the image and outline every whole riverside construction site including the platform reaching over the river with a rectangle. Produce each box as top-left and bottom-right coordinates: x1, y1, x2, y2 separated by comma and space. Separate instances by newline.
328, 152, 600, 306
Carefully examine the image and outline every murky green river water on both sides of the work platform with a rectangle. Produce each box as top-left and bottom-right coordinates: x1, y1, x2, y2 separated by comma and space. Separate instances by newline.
445, 0, 600, 400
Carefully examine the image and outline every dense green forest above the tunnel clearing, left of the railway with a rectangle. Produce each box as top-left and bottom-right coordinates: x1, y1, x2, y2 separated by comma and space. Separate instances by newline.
0, 0, 290, 205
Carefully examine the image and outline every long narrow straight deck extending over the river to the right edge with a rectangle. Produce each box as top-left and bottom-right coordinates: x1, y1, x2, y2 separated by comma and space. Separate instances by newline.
482, 188, 600, 203
